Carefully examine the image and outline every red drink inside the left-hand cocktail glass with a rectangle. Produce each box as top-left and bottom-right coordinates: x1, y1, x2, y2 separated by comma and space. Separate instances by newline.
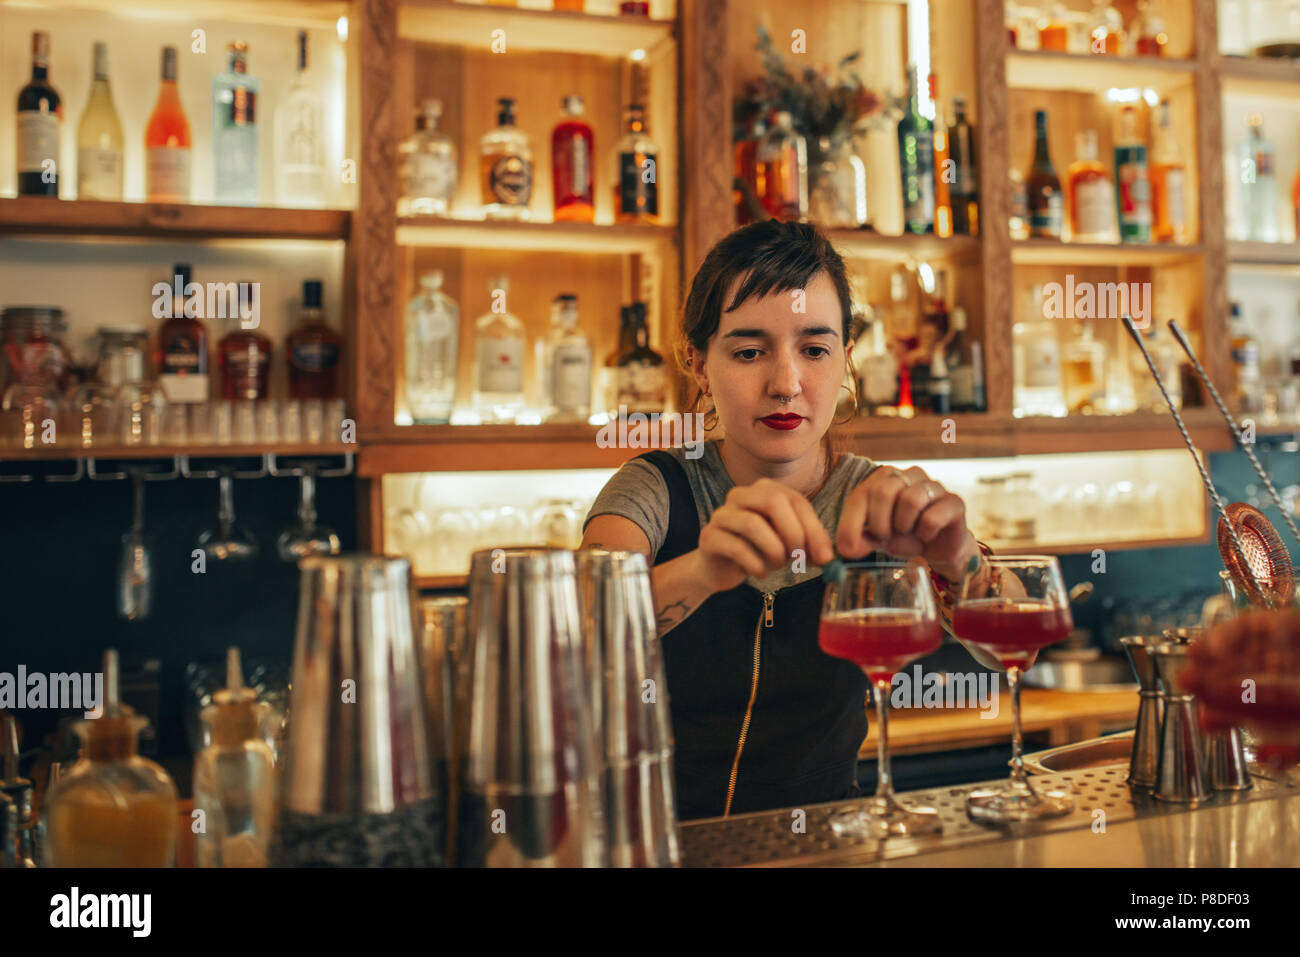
818, 609, 944, 683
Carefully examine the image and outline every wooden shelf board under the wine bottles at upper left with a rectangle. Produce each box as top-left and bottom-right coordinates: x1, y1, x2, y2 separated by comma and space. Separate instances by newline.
0, 196, 352, 241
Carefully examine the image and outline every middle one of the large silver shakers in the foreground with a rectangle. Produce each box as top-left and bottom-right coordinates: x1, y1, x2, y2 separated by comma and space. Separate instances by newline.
456, 547, 606, 867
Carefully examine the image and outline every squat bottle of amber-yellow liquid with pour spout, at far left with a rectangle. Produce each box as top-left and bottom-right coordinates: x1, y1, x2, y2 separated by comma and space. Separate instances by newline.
46, 649, 179, 867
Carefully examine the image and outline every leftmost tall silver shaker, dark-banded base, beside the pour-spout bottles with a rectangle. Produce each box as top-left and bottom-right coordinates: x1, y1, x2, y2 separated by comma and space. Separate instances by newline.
276, 555, 443, 866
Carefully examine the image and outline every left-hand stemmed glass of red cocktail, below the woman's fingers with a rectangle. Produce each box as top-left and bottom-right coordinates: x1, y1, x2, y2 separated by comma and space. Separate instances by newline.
818, 562, 943, 837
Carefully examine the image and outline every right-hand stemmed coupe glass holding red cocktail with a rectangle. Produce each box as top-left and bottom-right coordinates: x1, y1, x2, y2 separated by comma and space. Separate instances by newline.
953, 555, 1074, 824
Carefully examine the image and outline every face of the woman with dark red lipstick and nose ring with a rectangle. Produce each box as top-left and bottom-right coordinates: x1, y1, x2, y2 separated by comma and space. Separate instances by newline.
692, 272, 845, 462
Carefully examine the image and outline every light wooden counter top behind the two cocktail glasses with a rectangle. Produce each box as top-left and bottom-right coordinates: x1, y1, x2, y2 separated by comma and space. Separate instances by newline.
858, 687, 1138, 761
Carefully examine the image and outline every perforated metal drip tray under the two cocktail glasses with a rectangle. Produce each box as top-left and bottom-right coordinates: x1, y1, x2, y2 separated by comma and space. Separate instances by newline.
681, 766, 1286, 867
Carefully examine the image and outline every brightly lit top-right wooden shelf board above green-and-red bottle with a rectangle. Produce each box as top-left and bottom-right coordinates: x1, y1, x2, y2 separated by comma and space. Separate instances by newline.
1006, 49, 1196, 92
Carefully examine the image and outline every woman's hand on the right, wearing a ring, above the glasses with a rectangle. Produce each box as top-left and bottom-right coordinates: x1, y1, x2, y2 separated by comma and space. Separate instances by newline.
835, 465, 979, 581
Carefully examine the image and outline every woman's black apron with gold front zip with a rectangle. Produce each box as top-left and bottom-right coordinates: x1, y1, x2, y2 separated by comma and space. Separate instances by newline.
638, 450, 870, 820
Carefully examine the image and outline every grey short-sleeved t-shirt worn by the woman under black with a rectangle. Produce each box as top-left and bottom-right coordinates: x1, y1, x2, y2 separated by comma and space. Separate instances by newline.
582, 438, 876, 592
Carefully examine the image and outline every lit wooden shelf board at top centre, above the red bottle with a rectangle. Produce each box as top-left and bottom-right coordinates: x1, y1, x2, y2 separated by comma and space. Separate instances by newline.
398, 0, 676, 57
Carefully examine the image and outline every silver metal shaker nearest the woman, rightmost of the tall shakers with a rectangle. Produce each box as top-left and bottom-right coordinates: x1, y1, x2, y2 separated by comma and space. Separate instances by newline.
575, 549, 681, 867
